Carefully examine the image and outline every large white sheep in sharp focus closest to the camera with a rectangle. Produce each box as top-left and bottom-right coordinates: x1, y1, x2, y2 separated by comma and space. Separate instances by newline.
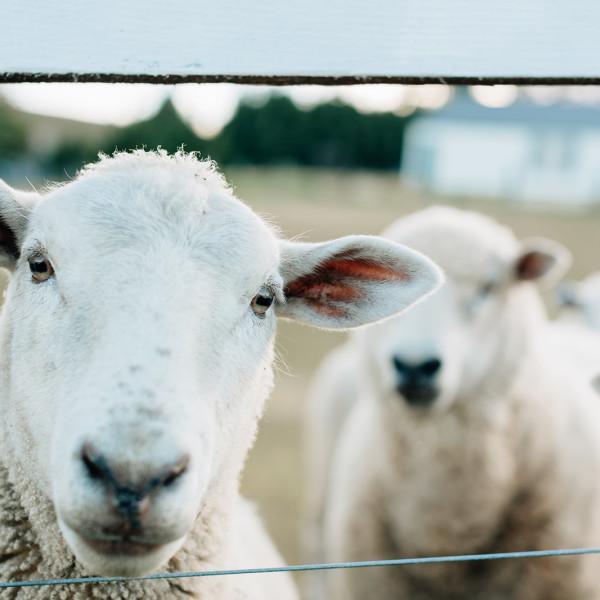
0, 151, 440, 600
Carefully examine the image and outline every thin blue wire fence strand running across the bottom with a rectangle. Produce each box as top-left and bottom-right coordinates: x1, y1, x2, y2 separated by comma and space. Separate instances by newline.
0, 548, 600, 589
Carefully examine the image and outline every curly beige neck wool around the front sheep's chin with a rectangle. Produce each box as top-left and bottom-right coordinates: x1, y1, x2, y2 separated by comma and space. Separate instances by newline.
0, 461, 241, 600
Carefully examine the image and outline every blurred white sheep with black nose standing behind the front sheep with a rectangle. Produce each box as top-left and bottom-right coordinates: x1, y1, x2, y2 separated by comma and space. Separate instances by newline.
307, 207, 600, 600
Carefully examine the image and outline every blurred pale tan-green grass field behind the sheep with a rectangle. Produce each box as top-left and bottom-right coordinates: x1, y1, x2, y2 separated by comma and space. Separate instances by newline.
227, 168, 600, 563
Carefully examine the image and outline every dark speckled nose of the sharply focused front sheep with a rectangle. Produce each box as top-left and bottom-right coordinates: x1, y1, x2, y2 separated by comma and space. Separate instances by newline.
81, 445, 189, 529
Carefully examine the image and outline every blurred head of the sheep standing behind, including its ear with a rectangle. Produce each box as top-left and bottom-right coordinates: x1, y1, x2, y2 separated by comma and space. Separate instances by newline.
359, 208, 568, 412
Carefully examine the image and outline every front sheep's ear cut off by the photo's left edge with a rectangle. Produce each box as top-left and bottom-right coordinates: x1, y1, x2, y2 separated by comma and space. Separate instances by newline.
0, 179, 39, 271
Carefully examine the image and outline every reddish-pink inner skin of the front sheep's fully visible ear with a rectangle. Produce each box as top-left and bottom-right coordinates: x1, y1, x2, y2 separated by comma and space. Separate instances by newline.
284, 258, 410, 317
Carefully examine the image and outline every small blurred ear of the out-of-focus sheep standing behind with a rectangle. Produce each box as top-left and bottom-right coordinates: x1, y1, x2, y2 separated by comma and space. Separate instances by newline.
515, 238, 572, 286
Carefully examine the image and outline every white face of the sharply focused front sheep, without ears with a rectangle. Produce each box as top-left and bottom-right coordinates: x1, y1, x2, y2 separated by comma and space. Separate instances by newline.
5, 161, 282, 575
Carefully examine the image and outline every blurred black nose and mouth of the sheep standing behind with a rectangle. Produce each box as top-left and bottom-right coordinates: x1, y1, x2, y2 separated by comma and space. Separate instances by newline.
392, 356, 442, 406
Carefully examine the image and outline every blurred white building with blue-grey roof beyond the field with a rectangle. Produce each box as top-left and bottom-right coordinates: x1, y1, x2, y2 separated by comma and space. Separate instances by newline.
402, 93, 600, 204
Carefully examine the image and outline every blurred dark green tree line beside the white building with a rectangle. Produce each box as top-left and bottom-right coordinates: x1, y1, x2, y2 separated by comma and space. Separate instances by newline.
0, 95, 410, 174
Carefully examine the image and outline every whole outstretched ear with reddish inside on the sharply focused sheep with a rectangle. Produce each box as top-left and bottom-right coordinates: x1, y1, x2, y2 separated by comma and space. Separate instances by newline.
275, 236, 442, 329
